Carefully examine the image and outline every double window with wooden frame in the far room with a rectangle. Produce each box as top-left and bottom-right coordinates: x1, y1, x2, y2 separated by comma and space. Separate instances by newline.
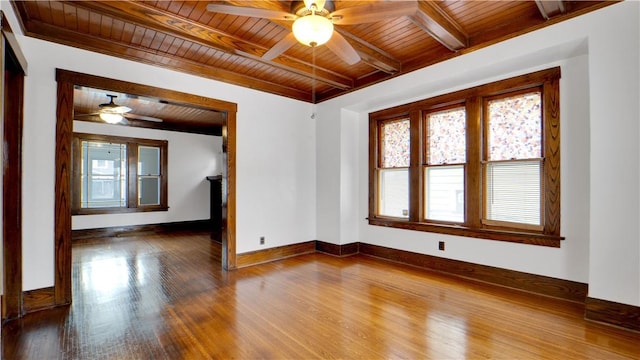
72, 133, 168, 215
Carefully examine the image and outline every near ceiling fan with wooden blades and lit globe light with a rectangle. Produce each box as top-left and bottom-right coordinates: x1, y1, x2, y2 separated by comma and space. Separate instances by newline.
207, 0, 418, 65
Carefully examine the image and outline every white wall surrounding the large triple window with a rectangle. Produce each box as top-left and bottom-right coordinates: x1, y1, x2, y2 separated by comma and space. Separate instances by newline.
316, 1, 640, 305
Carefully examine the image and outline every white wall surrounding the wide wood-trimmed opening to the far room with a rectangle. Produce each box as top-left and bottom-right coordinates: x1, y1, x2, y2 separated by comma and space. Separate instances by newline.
1, 1, 316, 291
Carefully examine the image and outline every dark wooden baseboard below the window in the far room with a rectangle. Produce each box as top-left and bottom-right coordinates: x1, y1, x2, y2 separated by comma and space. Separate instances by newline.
71, 220, 211, 240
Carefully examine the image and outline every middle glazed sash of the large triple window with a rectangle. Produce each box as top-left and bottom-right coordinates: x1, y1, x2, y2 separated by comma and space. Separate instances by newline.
424, 106, 467, 223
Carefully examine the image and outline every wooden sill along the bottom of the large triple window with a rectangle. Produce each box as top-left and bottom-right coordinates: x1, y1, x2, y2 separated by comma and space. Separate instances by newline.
369, 218, 564, 248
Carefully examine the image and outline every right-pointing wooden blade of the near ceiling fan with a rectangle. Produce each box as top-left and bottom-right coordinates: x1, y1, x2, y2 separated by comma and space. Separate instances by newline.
329, 1, 418, 25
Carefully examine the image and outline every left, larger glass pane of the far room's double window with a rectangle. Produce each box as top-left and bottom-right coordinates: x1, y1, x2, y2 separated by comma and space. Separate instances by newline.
80, 141, 127, 208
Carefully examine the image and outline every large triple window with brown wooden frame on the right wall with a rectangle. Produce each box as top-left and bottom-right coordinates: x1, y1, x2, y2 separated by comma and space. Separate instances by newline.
369, 68, 562, 247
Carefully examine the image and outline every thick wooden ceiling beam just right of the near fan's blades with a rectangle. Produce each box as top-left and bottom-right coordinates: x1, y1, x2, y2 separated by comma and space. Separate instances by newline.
411, 0, 469, 51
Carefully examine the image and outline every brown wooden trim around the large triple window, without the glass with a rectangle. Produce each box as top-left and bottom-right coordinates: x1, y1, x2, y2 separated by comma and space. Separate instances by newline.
369, 67, 564, 247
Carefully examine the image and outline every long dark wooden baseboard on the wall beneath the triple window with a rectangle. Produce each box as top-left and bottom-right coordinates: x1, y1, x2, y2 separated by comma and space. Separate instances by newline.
360, 243, 588, 302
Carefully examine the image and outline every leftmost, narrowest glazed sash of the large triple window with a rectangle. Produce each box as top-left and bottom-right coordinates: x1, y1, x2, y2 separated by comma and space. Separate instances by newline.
378, 119, 410, 218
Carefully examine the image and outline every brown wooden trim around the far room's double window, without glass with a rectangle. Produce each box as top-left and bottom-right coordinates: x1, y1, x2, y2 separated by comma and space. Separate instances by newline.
71, 133, 169, 215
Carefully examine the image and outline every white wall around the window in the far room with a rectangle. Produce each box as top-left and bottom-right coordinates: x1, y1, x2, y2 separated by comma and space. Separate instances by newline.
72, 121, 223, 230
